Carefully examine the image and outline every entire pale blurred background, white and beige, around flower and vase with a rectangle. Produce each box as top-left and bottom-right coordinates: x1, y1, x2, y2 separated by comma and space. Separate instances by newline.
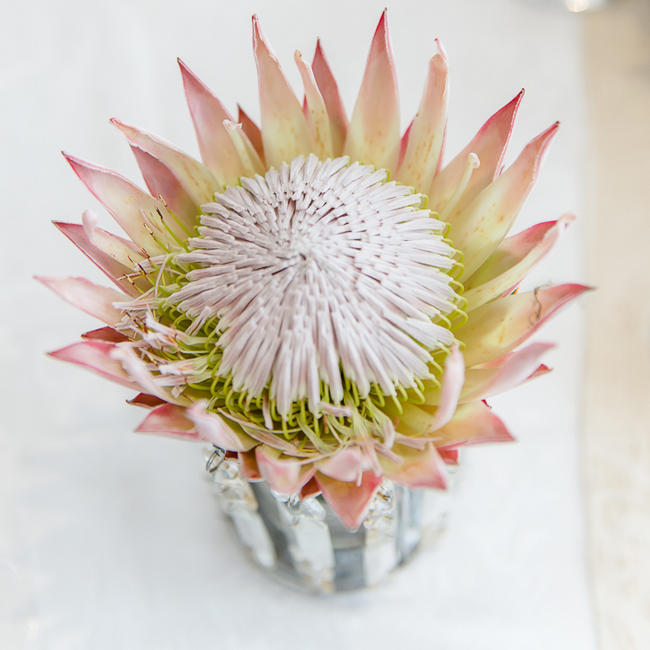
0, 0, 650, 650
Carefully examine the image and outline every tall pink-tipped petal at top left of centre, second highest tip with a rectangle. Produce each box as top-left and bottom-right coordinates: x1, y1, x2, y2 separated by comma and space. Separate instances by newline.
253, 16, 311, 167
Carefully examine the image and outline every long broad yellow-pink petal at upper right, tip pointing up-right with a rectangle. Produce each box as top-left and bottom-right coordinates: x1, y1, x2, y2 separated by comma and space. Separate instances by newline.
449, 122, 559, 280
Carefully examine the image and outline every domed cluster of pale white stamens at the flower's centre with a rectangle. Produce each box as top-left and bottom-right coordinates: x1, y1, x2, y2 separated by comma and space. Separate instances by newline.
170, 155, 456, 415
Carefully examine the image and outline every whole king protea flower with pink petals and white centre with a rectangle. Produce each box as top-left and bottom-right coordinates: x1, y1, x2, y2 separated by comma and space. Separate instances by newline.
40, 12, 586, 527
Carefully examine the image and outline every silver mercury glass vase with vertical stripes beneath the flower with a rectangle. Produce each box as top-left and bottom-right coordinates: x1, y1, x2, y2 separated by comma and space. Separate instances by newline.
206, 449, 449, 594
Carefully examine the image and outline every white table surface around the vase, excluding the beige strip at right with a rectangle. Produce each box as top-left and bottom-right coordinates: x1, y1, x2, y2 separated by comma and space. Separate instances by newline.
0, 0, 595, 650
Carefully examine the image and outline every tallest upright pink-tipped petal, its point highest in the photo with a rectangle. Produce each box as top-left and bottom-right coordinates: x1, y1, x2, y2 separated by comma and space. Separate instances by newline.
345, 10, 400, 170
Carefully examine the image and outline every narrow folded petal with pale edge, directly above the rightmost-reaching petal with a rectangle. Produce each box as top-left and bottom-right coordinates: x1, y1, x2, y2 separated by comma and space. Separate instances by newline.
463, 215, 575, 312
